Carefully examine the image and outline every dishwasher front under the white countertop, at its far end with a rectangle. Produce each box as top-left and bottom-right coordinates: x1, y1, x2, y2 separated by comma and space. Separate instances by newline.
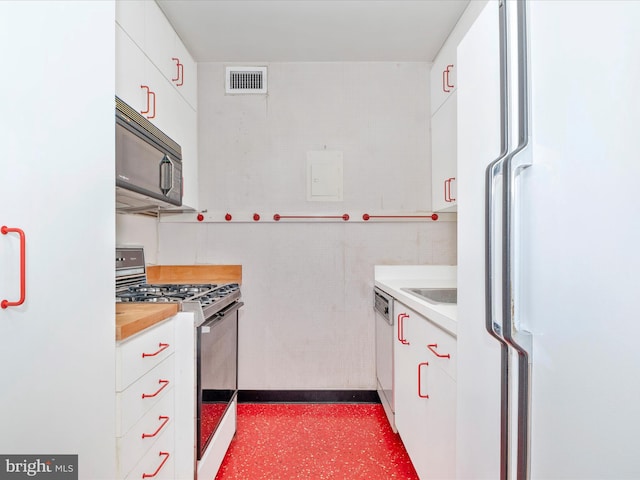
373, 287, 397, 432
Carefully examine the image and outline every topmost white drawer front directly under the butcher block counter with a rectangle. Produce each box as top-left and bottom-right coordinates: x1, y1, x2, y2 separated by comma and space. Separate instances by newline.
116, 320, 175, 392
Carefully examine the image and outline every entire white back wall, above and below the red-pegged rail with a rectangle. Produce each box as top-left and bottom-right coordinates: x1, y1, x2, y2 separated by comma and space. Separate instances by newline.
158, 63, 456, 389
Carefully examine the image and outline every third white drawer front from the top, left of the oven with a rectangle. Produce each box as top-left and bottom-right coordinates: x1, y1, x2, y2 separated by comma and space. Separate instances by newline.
116, 388, 174, 477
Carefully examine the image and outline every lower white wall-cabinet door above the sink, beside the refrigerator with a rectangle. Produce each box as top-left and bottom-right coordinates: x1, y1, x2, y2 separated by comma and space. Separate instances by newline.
431, 92, 457, 212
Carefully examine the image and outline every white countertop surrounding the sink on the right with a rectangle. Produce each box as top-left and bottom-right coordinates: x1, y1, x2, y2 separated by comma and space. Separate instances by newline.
374, 265, 458, 336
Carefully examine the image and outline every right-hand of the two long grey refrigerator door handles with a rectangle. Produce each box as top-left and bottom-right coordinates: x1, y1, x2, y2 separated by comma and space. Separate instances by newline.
502, 0, 532, 480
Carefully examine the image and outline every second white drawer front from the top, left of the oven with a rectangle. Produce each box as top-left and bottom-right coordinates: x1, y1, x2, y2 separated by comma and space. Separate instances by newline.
116, 356, 175, 437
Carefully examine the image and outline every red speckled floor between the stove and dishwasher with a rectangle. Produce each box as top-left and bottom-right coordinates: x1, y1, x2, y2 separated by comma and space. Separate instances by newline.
215, 403, 418, 480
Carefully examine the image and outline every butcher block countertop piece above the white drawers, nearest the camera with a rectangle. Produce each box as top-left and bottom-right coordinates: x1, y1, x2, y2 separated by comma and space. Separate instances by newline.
116, 303, 178, 341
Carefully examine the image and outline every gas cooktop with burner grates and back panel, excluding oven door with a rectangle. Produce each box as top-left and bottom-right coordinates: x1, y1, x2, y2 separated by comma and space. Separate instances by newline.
116, 247, 241, 326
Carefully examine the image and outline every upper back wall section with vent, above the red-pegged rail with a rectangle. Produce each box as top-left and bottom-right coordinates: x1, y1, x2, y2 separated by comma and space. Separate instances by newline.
198, 63, 431, 213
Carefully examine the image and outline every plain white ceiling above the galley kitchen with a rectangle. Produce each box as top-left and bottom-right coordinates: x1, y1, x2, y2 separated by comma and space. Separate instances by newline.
157, 0, 469, 62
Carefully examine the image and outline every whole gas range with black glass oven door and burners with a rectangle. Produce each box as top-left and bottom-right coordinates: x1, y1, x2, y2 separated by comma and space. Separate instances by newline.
116, 247, 244, 461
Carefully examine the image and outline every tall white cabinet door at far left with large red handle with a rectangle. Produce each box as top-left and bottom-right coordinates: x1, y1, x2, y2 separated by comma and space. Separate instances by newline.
0, 1, 115, 478
